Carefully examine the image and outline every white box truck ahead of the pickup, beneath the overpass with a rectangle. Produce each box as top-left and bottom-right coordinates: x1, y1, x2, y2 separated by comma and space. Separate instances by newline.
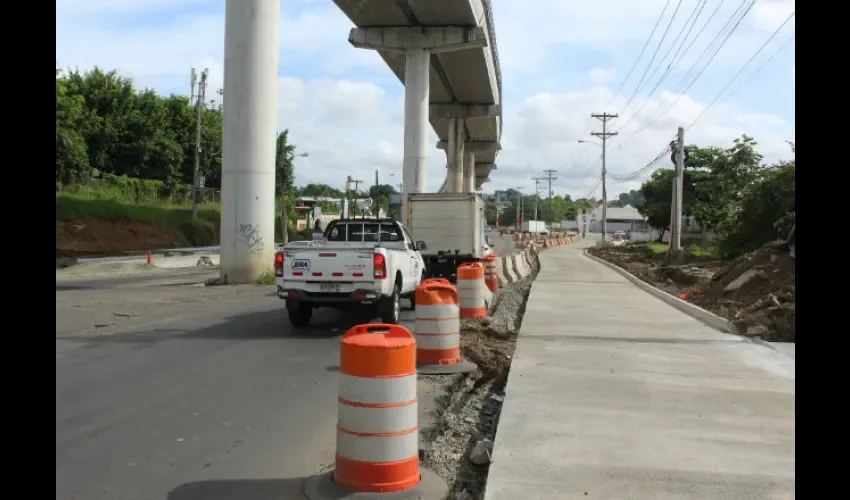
407, 193, 488, 281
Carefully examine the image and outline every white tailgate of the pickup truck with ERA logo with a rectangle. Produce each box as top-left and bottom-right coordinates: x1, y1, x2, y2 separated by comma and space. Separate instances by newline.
283, 247, 374, 283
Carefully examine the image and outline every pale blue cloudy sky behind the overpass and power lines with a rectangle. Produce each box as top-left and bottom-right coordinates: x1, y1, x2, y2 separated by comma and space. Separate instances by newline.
56, 0, 795, 199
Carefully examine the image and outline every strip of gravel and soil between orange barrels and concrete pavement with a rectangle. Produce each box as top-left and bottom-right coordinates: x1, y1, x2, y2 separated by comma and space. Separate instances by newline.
420, 256, 537, 500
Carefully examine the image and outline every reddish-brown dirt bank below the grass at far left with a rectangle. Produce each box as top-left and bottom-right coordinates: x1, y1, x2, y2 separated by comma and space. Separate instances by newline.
56, 218, 190, 257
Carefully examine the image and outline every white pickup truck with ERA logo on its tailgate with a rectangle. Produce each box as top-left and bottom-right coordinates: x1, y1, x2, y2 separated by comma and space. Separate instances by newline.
274, 218, 426, 327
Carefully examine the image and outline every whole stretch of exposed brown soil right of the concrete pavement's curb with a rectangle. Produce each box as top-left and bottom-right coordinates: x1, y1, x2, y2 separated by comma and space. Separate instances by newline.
588, 242, 796, 342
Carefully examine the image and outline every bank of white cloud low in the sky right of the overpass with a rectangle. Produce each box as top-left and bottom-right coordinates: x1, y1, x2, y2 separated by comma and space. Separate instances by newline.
488, 83, 794, 198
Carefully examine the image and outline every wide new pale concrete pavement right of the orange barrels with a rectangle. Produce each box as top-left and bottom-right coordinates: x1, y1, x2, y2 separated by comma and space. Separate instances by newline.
485, 242, 795, 500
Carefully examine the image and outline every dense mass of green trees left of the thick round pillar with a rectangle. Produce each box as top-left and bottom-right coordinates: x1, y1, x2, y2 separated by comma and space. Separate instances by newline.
56, 67, 227, 190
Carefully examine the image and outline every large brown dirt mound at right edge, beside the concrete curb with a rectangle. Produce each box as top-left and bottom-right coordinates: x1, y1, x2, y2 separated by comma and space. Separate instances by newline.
688, 242, 796, 341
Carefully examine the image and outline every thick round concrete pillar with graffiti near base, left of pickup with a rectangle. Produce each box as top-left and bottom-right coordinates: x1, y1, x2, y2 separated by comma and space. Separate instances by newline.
220, 0, 280, 283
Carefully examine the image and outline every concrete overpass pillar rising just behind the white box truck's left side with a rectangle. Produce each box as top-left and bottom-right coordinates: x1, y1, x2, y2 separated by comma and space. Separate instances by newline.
401, 48, 431, 225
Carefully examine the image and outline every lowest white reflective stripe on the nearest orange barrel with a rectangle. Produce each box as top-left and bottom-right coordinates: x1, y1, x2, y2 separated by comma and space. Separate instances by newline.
336, 427, 419, 462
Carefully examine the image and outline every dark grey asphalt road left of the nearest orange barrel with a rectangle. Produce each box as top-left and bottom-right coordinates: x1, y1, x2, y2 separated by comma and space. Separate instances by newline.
56, 276, 378, 500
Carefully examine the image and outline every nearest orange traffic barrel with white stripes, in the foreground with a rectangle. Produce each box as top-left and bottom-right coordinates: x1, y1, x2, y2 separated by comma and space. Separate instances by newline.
333, 324, 420, 493
